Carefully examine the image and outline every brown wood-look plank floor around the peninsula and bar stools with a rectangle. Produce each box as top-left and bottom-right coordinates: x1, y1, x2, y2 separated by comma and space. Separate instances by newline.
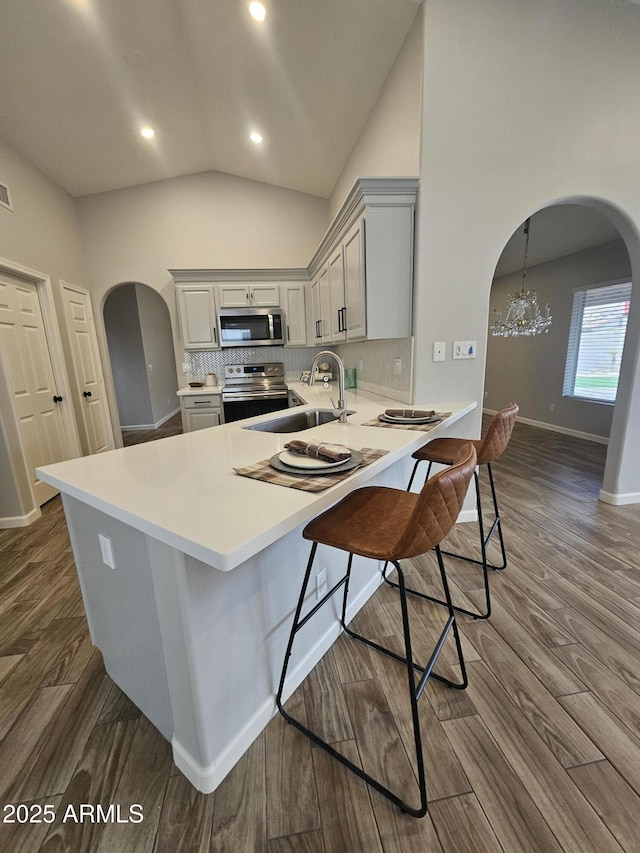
0, 424, 640, 853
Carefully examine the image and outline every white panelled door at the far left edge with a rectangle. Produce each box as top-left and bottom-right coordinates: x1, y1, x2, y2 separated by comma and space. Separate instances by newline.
0, 274, 70, 506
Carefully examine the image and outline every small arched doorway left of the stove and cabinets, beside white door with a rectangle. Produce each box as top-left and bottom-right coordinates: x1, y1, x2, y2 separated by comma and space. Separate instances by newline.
103, 282, 179, 442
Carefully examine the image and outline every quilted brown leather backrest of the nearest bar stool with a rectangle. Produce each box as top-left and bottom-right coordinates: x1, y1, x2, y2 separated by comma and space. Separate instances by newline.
391, 441, 477, 560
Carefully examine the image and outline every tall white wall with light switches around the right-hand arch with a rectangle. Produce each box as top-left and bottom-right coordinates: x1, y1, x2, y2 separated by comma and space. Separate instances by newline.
415, 0, 640, 499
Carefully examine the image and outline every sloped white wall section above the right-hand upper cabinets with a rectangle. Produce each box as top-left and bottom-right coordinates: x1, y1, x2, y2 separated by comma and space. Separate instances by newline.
329, 10, 423, 218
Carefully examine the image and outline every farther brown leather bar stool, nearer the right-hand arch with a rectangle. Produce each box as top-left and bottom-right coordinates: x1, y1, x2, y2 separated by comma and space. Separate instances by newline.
396, 403, 519, 619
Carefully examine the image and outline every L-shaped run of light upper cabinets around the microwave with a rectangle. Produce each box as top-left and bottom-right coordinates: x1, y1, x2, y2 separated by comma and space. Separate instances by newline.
170, 178, 418, 349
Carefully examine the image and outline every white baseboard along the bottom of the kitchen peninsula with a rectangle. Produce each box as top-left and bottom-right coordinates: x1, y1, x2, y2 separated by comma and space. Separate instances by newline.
171, 564, 383, 794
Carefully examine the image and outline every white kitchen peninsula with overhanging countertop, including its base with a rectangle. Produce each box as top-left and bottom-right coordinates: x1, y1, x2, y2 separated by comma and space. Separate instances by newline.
39, 383, 476, 793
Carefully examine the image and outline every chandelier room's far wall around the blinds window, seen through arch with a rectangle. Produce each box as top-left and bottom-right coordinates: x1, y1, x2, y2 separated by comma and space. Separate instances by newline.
484, 240, 631, 437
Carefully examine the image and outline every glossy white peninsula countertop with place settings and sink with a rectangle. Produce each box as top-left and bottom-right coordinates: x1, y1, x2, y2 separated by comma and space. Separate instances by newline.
38, 382, 477, 571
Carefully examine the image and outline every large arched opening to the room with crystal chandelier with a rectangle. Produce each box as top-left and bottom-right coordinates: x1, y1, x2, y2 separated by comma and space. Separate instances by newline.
484, 200, 633, 500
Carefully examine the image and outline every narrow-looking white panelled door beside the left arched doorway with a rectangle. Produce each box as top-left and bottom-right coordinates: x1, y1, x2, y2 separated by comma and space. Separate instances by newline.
62, 284, 114, 453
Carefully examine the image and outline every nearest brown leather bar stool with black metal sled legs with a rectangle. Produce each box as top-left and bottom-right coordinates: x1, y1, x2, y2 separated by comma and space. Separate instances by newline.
276, 442, 476, 817
